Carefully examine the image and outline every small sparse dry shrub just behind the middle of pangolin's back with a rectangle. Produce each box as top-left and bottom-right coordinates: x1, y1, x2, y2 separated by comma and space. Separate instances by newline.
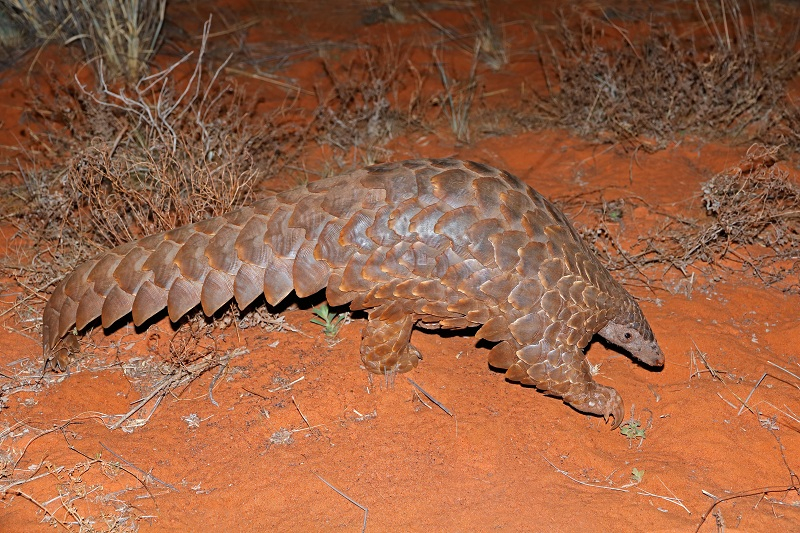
315, 42, 424, 163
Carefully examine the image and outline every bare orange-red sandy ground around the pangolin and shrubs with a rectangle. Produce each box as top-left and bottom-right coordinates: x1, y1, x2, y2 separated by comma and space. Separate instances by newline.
0, 4, 800, 532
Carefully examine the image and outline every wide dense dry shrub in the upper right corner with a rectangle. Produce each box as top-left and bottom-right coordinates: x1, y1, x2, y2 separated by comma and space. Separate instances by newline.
529, 0, 800, 150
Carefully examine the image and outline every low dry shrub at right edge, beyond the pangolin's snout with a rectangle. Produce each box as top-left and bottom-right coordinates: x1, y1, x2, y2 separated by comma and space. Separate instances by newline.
561, 144, 800, 293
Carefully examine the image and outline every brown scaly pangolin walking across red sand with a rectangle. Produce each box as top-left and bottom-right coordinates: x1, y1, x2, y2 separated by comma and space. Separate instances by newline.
43, 159, 664, 427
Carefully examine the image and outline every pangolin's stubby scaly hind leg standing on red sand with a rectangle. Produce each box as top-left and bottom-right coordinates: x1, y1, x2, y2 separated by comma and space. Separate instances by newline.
361, 302, 422, 374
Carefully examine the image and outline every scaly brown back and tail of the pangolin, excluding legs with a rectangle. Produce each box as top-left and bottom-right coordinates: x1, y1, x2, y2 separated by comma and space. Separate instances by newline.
43, 159, 635, 364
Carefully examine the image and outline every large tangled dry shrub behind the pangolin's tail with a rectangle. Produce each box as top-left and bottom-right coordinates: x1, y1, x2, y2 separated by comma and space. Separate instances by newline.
6, 22, 304, 287
